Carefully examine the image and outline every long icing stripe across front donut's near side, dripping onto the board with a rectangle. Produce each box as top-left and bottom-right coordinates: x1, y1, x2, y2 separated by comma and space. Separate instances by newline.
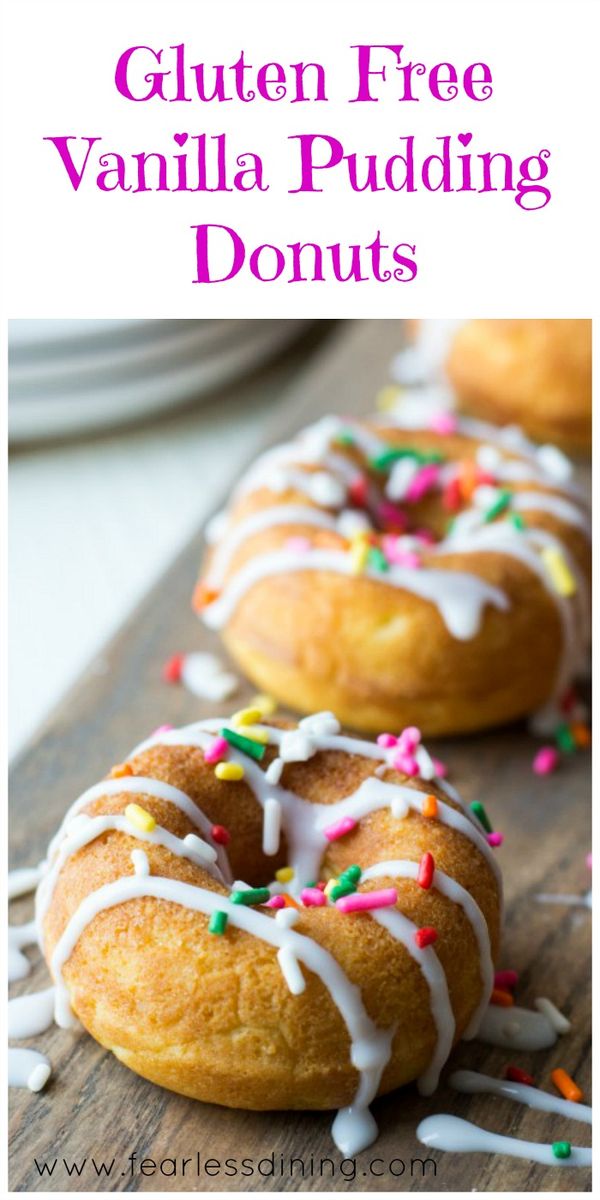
52, 875, 392, 1154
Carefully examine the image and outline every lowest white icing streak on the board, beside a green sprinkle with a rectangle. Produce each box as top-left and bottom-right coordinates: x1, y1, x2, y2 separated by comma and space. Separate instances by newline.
416, 1112, 592, 1166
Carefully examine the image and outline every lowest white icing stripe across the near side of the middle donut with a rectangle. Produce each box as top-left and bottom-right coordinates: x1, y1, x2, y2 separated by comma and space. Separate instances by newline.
203, 548, 509, 641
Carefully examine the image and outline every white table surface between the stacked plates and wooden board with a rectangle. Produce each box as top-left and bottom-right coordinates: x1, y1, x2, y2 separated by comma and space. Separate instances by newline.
8, 358, 309, 757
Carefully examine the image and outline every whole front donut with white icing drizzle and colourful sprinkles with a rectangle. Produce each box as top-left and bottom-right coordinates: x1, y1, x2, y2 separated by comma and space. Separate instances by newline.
36, 710, 500, 1154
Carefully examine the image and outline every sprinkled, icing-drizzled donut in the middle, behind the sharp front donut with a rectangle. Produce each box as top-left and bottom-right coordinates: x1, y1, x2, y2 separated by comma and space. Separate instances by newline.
194, 403, 589, 734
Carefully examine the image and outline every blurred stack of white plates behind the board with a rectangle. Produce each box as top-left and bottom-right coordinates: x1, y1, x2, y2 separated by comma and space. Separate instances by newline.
8, 319, 310, 443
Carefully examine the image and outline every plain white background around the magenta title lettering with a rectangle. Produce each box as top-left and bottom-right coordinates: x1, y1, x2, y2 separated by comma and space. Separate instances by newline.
5, 0, 598, 317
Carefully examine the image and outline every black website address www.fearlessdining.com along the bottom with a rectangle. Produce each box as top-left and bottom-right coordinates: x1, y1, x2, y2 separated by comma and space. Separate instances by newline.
34, 1153, 437, 1182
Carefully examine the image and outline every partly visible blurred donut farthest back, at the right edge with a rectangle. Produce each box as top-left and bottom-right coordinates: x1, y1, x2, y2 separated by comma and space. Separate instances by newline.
445, 320, 592, 452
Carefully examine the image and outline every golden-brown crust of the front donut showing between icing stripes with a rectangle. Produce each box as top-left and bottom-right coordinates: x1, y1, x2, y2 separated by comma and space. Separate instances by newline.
44, 746, 499, 1109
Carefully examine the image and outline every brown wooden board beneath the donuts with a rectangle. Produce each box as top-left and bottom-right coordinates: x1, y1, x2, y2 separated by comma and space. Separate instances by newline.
10, 322, 590, 1192
